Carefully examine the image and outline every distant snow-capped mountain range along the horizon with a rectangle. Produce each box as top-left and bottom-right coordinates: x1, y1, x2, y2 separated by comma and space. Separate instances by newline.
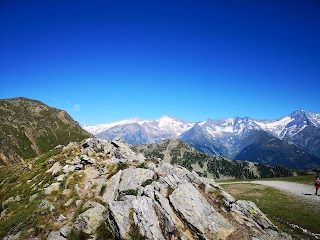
83, 110, 320, 169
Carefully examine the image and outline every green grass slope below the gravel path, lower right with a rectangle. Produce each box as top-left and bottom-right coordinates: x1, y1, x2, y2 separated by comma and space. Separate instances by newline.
223, 184, 320, 239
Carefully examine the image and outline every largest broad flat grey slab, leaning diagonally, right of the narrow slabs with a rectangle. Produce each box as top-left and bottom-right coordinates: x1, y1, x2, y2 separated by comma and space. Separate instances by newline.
169, 183, 233, 239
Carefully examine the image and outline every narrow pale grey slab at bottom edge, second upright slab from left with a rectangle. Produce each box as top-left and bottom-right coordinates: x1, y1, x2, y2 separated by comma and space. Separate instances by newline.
133, 196, 165, 239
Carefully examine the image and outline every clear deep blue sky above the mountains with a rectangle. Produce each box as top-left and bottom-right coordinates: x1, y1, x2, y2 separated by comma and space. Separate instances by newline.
0, 0, 320, 125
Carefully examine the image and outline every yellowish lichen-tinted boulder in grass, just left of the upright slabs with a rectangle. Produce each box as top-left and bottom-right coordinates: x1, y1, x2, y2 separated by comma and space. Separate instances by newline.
73, 203, 106, 234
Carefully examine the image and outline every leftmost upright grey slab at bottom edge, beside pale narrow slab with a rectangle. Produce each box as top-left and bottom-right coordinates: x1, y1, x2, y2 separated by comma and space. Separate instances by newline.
107, 201, 133, 239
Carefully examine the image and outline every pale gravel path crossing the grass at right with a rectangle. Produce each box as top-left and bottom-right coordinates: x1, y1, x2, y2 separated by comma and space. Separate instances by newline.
218, 181, 320, 202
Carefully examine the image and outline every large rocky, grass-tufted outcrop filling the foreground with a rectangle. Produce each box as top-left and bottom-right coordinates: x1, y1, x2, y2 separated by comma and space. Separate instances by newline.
0, 138, 291, 240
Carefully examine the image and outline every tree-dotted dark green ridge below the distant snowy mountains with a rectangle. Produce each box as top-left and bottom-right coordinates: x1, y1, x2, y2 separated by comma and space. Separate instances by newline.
131, 139, 298, 179
